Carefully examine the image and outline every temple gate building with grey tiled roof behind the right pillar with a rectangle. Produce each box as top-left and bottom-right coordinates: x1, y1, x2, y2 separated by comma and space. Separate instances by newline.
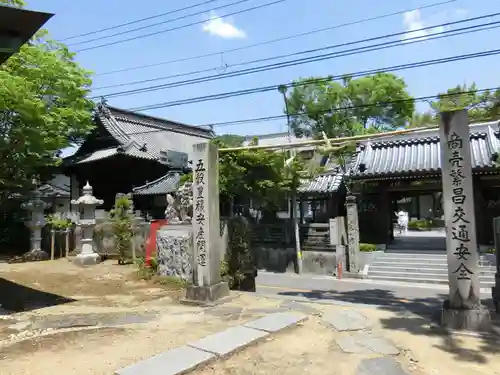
300, 121, 500, 246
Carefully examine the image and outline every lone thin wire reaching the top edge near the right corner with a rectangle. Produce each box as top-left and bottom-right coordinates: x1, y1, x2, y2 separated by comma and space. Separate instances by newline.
95, 0, 457, 76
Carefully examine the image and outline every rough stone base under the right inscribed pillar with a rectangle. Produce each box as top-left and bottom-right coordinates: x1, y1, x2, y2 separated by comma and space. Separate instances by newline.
441, 301, 491, 331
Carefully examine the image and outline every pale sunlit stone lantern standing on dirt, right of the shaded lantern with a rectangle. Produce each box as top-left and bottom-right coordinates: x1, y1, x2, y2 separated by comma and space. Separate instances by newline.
71, 182, 104, 266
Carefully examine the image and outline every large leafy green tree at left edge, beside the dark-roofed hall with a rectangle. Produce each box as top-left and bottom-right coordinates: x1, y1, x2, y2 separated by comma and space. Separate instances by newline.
0, 0, 93, 202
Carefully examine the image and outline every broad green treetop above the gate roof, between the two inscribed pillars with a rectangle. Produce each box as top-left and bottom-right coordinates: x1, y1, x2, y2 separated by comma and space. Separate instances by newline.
287, 73, 415, 138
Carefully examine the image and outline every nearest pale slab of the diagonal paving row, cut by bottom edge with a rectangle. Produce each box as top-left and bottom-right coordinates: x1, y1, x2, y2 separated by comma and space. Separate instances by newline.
115, 346, 216, 375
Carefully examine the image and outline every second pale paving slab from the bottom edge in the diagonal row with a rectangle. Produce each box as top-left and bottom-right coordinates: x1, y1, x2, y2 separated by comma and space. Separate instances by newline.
188, 326, 269, 357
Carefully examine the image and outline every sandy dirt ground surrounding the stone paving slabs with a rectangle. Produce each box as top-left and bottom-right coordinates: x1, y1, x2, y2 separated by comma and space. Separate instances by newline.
0, 260, 500, 375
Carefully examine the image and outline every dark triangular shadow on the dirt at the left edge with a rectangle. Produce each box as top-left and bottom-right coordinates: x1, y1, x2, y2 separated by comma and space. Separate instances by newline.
0, 277, 76, 313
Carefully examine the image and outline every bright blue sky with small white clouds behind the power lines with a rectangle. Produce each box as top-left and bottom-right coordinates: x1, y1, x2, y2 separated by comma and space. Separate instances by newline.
28, 0, 500, 141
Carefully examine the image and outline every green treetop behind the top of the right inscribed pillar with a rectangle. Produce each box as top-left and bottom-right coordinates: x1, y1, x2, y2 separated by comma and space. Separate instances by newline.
431, 83, 500, 122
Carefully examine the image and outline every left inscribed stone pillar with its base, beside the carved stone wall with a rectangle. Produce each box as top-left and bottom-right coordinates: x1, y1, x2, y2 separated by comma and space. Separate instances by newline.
186, 142, 229, 303
